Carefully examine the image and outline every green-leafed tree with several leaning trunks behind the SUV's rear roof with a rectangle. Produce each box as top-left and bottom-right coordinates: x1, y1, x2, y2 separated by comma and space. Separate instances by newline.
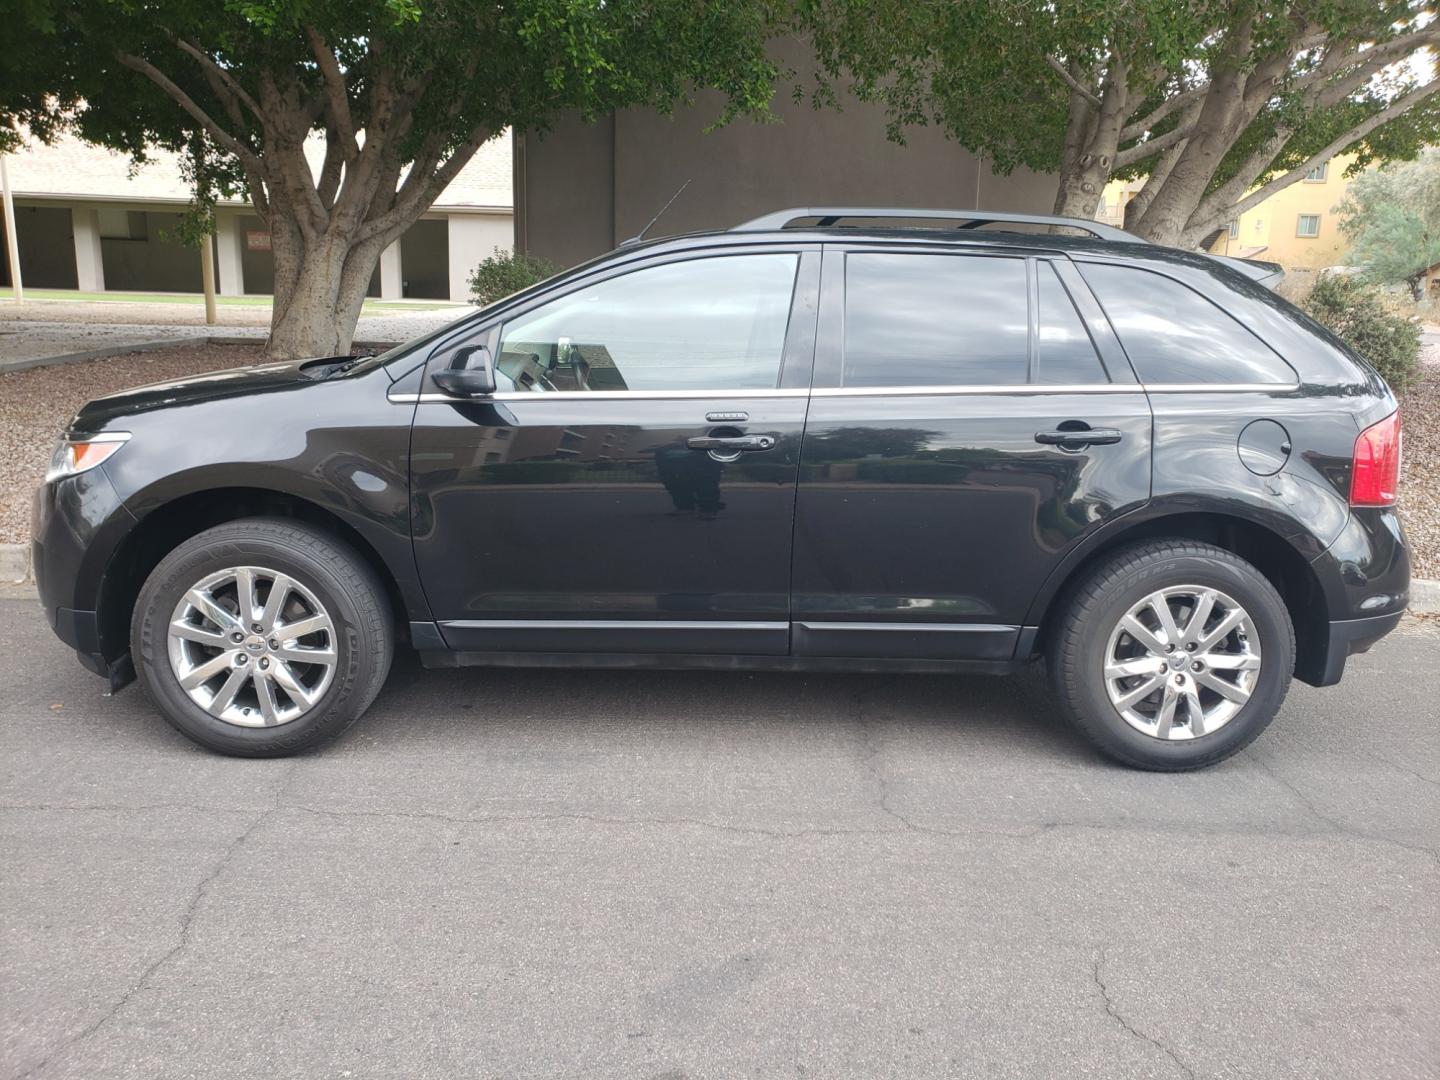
799, 0, 1440, 246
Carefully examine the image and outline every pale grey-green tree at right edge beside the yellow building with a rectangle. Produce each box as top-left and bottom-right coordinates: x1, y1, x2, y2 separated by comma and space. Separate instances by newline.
1339, 148, 1440, 301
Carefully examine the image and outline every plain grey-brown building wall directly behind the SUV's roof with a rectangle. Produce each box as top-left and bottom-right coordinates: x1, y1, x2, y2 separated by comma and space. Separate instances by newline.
514, 45, 1056, 265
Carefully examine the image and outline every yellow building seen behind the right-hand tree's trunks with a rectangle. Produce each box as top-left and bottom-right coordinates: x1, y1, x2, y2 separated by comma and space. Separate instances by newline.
1097, 154, 1354, 269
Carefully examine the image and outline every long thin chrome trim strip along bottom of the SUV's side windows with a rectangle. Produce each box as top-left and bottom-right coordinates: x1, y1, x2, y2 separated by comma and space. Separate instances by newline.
397, 383, 1300, 405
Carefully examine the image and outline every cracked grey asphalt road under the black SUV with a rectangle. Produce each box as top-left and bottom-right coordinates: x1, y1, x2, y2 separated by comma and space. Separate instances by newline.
0, 595, 1440, 1080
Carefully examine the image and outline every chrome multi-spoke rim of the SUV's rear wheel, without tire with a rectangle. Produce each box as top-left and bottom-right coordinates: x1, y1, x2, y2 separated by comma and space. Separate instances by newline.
1104, 585, 1260, 740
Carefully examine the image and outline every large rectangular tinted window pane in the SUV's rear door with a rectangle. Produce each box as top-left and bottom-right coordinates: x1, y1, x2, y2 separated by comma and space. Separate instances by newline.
844, 253, 1030, 386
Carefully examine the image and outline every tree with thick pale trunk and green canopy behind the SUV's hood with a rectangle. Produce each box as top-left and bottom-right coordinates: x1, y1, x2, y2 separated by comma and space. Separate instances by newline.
0, 0, 776, 357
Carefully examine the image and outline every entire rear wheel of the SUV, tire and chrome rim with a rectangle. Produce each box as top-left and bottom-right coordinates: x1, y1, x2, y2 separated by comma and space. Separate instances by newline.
1050, 540, 1295, 770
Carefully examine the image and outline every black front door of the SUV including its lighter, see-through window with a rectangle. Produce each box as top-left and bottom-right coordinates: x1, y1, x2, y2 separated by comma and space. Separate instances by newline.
410, 246, 821, 655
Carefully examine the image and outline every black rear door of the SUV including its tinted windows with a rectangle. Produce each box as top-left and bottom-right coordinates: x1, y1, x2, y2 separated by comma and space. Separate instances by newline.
793, 246, 1151, 660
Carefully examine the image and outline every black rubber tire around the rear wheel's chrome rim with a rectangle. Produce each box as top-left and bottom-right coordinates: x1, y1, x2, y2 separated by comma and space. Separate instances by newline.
1048, 539, 1295, 772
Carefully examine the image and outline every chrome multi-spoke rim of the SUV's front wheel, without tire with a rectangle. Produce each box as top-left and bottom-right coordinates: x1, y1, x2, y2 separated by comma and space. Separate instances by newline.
167, 566, 336, 727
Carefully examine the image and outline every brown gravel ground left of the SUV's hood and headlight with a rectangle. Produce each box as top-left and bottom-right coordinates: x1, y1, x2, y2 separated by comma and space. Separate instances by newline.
0, 344, 261, 544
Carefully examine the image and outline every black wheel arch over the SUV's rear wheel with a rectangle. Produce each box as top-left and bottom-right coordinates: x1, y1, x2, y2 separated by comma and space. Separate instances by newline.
1025, 510, 1329, 683
